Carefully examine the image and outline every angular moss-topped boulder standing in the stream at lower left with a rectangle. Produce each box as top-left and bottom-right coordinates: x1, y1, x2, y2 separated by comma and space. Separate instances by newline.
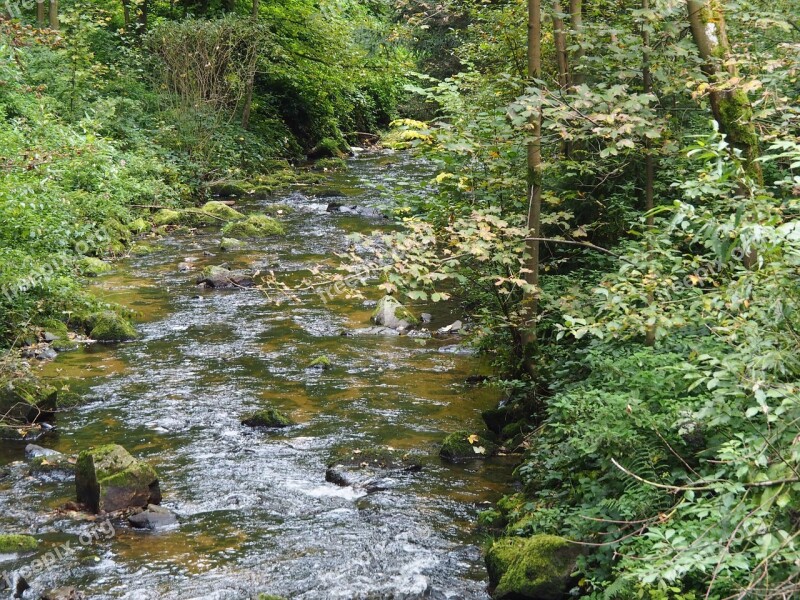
75, 444, 161, 513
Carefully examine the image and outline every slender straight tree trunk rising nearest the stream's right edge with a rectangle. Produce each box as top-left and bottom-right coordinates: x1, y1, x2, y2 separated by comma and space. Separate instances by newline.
523, 0, 542, 375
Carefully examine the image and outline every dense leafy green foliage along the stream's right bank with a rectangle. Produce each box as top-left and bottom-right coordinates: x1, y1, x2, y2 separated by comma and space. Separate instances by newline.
360, 1, 800, 599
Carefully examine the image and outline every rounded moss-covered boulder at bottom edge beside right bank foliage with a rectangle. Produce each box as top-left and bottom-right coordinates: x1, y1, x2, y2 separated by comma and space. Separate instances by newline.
486, 535, 580, 600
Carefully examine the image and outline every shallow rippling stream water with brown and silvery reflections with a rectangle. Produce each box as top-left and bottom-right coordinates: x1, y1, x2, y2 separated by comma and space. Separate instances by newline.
0, 153, 510, 599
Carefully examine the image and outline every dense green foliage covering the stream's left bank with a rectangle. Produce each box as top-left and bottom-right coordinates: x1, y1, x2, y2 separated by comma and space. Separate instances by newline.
0, 0, 407, 345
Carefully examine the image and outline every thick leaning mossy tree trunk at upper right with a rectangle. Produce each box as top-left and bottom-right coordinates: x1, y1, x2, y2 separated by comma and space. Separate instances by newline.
687, 0, 763, 183
